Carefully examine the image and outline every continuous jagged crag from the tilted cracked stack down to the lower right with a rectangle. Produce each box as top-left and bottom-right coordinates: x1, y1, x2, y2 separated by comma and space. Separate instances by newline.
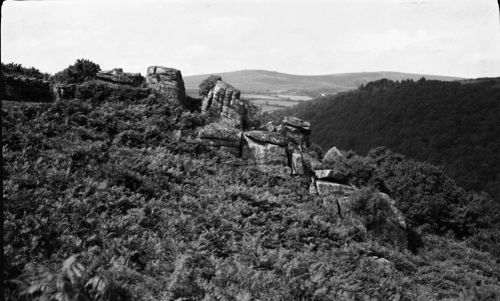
193, 76, 407, 248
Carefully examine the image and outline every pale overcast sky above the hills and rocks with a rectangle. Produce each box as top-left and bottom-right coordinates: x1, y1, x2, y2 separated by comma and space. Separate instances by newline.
1, 0, 500, 77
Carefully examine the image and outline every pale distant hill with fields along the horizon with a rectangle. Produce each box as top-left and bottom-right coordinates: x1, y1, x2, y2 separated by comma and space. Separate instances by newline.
184, 70, 460, 93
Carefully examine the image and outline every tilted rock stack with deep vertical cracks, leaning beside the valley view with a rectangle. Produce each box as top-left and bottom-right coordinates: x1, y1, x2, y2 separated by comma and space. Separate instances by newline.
201, 80, 248, 129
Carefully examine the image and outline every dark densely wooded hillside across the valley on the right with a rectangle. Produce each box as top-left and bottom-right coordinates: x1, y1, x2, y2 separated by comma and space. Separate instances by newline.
279, 78, 500, 202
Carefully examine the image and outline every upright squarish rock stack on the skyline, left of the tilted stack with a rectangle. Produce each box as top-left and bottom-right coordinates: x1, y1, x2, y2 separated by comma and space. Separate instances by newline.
146, 66, 186, 101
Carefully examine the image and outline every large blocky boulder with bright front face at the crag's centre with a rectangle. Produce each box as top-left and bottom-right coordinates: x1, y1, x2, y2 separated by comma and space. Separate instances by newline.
241, 131, 288, 166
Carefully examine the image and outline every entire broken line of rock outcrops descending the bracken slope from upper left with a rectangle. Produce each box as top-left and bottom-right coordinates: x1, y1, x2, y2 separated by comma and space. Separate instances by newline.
47, 66, 407, 248
